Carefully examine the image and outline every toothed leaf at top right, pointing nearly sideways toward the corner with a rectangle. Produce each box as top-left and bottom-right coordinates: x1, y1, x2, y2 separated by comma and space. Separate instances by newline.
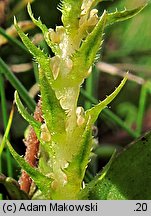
106, 3, 147, 25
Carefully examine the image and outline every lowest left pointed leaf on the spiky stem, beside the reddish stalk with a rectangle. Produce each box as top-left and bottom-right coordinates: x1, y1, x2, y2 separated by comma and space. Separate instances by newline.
7, 141, 51, 199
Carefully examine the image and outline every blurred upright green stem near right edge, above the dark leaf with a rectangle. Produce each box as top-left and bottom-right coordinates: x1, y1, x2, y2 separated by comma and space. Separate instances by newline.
136, 84, 148, 135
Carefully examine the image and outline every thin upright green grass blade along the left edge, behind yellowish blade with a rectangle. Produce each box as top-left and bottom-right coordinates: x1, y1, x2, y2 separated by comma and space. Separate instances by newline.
0, 74, 13, 177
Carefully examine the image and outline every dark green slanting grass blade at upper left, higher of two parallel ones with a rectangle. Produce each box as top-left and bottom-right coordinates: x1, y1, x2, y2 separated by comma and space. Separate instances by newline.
0, 27, 30, 54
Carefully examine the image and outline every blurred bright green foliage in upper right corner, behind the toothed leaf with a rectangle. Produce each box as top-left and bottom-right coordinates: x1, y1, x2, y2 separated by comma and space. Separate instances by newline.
106, 0, 151, 65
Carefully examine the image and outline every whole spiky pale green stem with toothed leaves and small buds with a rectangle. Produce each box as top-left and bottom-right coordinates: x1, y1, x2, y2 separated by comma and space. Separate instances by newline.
8, 0, 144, 199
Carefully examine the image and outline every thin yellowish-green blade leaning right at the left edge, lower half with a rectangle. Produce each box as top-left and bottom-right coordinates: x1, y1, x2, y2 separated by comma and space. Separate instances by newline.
0, 105, 14, 157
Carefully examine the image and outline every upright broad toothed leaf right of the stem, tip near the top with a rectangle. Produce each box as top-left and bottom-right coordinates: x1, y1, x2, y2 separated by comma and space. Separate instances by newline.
72, 11, 106, 82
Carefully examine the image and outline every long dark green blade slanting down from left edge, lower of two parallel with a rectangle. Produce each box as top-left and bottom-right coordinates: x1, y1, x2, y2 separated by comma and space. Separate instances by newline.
0, 58, 36, 112
